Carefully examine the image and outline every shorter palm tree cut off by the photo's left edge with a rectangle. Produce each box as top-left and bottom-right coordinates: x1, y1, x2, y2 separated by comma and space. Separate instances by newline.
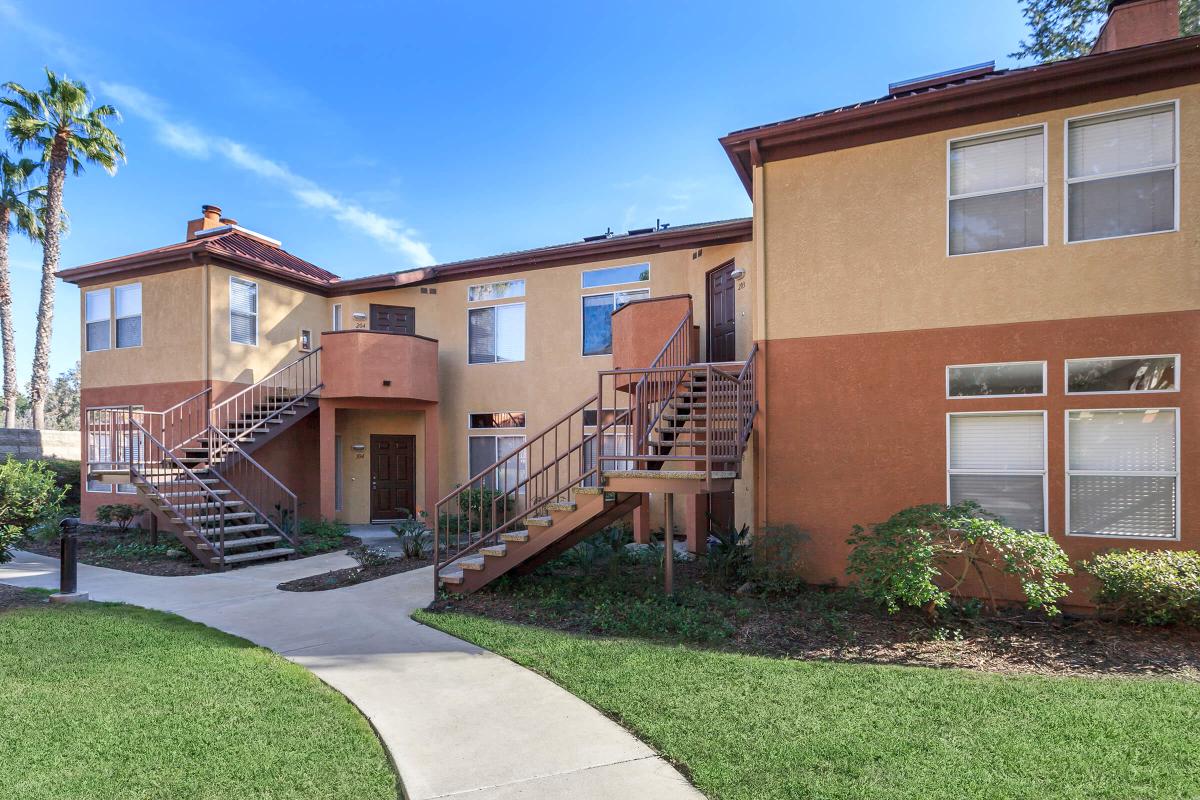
0, 152, 44, 428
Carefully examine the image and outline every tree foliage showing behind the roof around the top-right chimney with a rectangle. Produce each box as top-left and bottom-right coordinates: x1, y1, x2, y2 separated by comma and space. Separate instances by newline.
1009, 0, 1200, 62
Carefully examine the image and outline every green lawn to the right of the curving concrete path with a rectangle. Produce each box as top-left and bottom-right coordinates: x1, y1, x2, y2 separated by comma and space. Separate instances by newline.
415, 612, 1200, 800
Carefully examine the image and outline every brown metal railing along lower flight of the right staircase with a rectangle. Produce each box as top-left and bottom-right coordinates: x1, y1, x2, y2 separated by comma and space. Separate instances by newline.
433, 397, 598, 588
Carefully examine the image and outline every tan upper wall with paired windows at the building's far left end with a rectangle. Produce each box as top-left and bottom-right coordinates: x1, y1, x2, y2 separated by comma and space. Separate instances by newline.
79, 266, 205, 388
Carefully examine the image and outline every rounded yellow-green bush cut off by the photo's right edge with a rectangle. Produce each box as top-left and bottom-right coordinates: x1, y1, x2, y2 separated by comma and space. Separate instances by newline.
1080, 548, 1200, 625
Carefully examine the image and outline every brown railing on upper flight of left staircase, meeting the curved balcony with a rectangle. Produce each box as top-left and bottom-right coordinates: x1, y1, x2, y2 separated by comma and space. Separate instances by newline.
209, 348, 322, 456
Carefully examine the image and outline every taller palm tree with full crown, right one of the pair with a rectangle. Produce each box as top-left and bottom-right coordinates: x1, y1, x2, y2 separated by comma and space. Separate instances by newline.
0, 70, 125, 428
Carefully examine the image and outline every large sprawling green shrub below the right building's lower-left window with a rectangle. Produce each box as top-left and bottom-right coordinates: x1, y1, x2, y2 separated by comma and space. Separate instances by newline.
846, 501, 1072, 616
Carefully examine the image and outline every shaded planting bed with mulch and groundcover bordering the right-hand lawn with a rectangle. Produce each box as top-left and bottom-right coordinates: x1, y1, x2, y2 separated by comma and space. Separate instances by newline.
433, 558, 1200, 680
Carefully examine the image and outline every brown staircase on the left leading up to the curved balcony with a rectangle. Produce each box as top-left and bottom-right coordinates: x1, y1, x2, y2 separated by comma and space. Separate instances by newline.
85, 348, 320, 570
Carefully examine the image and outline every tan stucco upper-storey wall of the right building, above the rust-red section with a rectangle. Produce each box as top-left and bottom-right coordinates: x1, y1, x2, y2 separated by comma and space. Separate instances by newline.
755, 86, 1200, 339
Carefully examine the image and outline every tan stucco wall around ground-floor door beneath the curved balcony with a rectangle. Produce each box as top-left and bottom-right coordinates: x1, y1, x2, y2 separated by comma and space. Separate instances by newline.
337, 409, 425, 525
